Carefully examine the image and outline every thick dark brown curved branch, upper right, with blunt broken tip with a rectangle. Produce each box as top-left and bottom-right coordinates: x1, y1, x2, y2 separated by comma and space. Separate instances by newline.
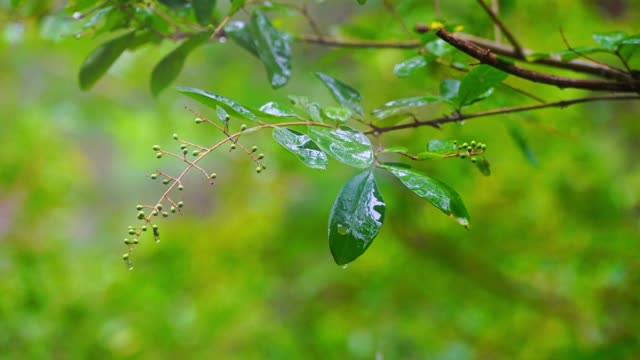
436, 29, 640, 92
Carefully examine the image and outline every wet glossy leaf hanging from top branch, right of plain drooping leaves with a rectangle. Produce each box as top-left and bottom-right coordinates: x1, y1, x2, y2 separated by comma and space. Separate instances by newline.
249, 10, 291, 88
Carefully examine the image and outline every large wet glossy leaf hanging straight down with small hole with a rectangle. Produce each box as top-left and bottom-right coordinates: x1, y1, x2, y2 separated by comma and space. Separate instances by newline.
329, 171, 386, 265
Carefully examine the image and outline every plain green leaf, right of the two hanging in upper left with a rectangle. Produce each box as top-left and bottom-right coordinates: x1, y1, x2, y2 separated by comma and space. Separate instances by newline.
151, 34, 209, 96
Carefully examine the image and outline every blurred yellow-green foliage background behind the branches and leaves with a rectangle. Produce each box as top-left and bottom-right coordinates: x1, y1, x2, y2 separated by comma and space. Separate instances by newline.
0, 0, 640, 359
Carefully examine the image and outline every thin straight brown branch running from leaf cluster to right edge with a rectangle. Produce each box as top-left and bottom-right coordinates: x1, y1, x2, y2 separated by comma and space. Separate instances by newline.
365, 95, 640, 135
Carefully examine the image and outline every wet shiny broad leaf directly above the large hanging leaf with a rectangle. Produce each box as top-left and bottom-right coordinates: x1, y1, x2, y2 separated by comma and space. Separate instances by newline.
309, 125, 373, 168
